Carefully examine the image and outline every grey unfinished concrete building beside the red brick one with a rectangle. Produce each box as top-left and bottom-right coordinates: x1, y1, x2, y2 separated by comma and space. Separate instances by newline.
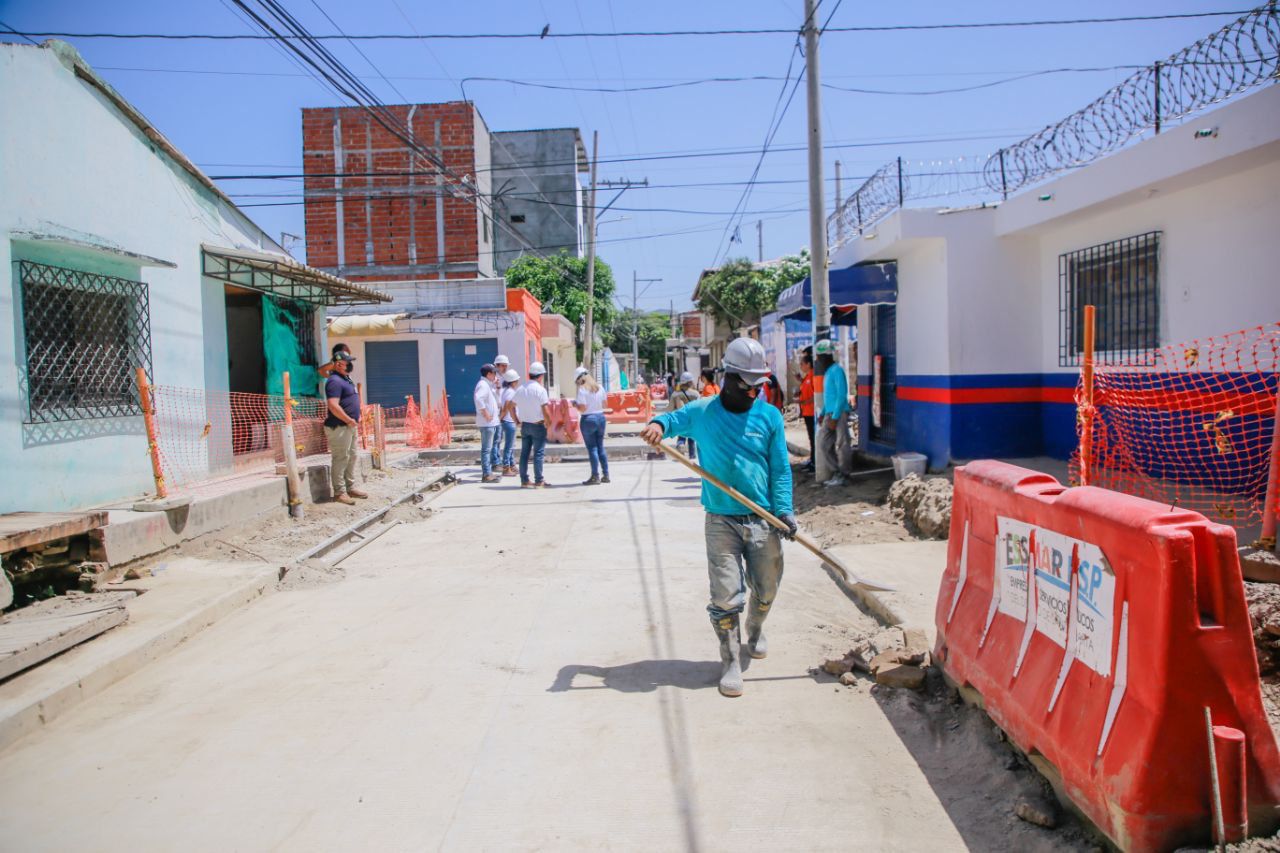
492, 128, 582, 275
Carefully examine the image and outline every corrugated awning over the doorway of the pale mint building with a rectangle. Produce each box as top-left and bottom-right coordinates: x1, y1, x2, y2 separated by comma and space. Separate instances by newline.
201, 243, 392, 305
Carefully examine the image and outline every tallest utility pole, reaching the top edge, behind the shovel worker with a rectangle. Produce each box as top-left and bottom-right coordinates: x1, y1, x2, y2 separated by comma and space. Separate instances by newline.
804, 0, 835, 483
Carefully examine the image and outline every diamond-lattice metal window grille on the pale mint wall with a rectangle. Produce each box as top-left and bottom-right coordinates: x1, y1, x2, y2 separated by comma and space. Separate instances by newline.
18, 261, 151, 424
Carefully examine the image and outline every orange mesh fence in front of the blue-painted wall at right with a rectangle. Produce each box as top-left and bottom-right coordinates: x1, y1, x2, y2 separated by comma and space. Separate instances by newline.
1071, 323, 1280, 526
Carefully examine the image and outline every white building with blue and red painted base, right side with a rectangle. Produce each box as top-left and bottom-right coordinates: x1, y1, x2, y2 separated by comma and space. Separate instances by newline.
831, 86, 1280, 466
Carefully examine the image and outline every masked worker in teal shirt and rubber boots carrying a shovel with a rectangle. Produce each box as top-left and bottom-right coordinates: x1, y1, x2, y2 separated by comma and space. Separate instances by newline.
640, 338, 796, 697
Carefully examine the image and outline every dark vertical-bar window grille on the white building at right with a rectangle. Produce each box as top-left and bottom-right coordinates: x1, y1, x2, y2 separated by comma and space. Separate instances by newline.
1057, 231, 1160, 366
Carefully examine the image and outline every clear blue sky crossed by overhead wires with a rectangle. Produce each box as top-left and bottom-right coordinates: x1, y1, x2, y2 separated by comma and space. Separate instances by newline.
0, 0, 1245, 310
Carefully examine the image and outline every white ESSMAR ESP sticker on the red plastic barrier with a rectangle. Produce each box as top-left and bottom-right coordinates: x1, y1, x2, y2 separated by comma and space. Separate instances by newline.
996, 517, 1116, 675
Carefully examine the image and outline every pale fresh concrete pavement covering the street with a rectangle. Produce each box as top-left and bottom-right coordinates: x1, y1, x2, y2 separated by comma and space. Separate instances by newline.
0, 461, 974, 850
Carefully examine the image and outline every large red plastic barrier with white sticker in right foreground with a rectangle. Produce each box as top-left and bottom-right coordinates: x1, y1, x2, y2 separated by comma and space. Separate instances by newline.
934, 461, 1280, 850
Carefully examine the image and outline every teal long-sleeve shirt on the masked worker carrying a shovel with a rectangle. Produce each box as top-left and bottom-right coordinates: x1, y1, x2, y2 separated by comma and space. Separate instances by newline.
653, 397, 794, 515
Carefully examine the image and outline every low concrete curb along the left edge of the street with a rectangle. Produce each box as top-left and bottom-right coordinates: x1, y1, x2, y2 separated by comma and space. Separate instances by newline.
0, 566, 279, 749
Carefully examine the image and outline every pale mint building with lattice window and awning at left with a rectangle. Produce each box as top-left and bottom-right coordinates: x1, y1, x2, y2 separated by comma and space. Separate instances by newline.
0, 41, 385, 512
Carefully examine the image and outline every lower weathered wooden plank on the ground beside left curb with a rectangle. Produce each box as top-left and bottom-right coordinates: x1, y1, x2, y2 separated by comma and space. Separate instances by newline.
0, 592, 134, 679
